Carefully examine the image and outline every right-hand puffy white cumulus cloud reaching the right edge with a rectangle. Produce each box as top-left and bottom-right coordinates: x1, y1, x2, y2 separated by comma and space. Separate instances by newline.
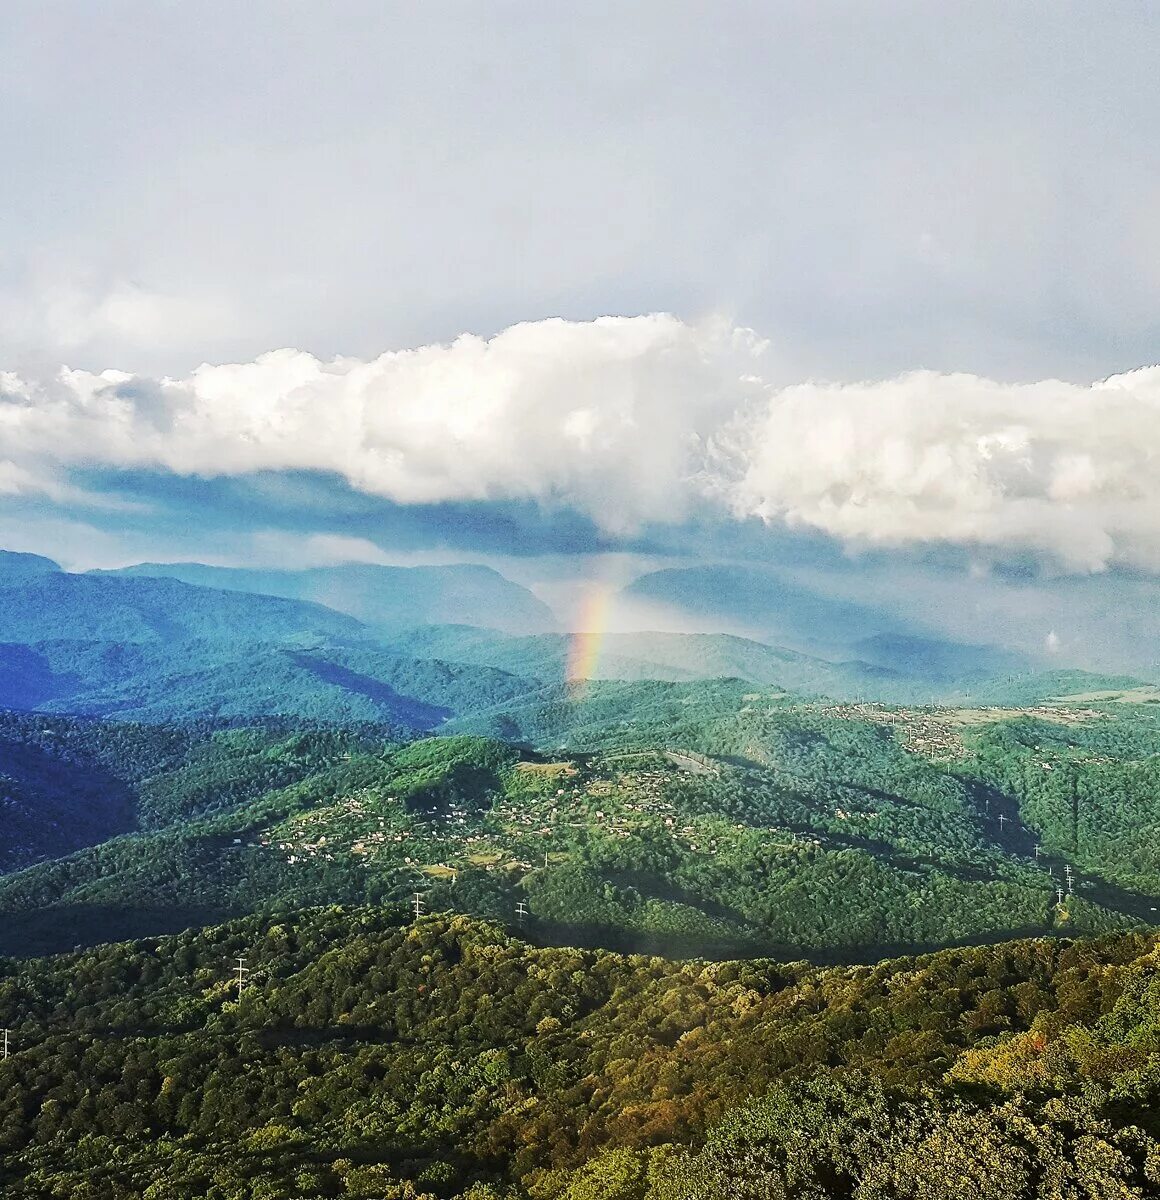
727, 367, 1160, 570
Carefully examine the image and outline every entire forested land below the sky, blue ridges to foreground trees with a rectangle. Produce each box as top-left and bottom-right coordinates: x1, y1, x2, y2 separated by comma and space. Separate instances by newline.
0, 564, 1160, 1200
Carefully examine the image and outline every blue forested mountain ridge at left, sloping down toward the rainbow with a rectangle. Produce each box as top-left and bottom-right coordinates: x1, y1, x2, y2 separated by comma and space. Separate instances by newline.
0, 556, 537, 731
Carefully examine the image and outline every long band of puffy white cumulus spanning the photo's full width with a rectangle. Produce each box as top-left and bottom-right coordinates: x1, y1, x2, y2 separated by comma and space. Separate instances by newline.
0, 314, 1160, 570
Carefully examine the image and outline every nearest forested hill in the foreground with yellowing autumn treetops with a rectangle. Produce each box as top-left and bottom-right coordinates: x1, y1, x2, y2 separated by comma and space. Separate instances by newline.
0, 908, 1160, 1200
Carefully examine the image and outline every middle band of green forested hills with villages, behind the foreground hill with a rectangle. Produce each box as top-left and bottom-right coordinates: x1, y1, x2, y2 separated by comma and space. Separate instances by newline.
0, 682, 1160, 961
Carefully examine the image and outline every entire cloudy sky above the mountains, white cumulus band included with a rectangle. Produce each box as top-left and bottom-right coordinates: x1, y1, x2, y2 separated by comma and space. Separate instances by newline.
0, 0, 1160, 657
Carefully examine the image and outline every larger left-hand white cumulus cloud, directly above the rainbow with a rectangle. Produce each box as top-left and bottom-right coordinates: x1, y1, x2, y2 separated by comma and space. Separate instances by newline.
0, 316, 762, 530
